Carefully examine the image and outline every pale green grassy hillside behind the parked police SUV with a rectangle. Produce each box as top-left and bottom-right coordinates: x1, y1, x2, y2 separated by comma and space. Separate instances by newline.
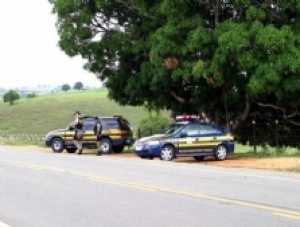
0, 90, 167, 134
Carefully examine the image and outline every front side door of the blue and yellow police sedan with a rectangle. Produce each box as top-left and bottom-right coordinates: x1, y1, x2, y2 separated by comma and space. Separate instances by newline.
179, 122, 200, 154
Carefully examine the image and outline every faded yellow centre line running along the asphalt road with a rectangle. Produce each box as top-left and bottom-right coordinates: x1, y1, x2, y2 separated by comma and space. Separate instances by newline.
1, 160, 300, 219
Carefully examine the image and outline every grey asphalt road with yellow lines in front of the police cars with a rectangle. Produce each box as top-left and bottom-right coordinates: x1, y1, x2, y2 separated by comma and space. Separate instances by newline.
0, 148, 300, 227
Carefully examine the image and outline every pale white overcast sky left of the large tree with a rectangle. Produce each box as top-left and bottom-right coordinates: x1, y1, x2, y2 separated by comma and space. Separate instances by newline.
0, 0, 101, 88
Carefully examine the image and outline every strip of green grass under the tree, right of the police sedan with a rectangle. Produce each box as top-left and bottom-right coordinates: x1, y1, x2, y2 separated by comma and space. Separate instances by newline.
232, 143, 300, 158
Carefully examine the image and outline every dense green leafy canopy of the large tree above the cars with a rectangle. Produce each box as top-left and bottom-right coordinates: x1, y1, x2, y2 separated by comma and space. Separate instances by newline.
49, 0, 300, 130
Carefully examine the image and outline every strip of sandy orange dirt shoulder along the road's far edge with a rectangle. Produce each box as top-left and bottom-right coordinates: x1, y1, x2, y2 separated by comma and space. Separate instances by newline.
0, 145, 300, 170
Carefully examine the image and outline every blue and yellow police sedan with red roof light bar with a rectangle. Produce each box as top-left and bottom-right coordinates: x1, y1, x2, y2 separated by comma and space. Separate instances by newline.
133, 115, 234, 161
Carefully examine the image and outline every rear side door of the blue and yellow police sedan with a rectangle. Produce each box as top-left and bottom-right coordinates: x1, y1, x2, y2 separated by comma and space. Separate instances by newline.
199, 124, 220, 152
